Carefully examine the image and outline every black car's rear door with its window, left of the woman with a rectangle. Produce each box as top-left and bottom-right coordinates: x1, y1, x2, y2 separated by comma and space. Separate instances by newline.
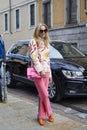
7, 42, 30, 80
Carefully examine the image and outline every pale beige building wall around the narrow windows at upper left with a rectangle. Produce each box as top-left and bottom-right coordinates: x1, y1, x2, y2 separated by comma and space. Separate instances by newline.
0, 0, 34, 50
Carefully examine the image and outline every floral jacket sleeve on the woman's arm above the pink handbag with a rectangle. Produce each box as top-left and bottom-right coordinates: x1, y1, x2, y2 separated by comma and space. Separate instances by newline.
29, 39, 43, 72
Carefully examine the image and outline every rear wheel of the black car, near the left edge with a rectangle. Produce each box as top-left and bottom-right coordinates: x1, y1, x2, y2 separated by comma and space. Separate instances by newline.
6, 69, 16, 88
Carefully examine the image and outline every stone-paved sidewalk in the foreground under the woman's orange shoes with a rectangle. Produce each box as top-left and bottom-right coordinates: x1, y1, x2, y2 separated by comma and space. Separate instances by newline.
0, 94, 87, 130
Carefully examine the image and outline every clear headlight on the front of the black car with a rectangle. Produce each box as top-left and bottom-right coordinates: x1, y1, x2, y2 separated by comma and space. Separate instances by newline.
62, 70, 83, 79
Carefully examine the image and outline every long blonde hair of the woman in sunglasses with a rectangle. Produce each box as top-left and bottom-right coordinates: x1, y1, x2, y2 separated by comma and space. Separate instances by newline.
33, 23, 50, 47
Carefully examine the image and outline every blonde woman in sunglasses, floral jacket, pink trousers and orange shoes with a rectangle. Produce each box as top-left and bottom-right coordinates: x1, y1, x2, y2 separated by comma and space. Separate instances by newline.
29, 24, 54, 125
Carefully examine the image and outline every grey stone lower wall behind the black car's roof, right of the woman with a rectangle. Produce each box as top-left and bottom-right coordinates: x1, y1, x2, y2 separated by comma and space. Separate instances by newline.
50, 26, 87, 52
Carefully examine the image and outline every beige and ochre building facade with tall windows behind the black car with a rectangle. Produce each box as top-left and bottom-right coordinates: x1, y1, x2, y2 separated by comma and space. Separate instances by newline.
0, 0, 87, 52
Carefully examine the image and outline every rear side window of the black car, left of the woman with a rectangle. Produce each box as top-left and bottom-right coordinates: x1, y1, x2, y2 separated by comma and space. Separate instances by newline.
10, 44, 28, 56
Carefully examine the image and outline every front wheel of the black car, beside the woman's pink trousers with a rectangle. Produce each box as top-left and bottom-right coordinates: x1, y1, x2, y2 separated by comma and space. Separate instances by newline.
48, 79, 62, 102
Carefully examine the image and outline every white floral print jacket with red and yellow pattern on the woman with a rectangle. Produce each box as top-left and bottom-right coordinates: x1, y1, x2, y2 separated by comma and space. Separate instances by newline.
29, 39, 51, 77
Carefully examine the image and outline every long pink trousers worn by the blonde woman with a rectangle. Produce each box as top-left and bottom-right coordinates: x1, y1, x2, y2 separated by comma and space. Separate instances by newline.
34, 73, 52, 119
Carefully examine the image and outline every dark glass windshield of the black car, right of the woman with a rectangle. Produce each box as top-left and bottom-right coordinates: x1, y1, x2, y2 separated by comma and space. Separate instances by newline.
51, 42, 85, 58
